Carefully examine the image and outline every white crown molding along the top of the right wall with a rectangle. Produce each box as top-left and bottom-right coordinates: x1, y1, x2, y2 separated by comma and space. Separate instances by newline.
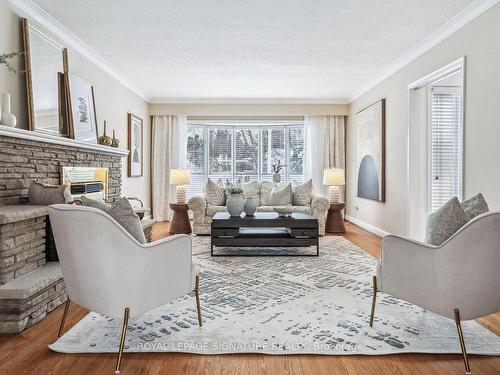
349, 0, 500, 103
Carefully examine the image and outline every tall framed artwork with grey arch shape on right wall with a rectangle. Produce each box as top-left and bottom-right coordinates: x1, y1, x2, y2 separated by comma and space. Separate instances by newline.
356, 99, 385, 202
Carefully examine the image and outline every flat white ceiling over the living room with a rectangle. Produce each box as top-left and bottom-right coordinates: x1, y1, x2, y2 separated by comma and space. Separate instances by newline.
33, 0, 474, 101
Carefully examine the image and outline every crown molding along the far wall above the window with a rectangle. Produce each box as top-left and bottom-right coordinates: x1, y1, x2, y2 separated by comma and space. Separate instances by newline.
149, 98, 349, 104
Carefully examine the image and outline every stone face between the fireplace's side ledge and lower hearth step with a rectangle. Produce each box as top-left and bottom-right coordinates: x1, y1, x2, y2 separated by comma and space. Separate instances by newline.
0, 217, 45, 285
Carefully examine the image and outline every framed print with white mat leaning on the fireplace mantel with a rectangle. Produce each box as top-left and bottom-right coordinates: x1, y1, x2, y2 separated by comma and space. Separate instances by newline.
68, 73, 97, 143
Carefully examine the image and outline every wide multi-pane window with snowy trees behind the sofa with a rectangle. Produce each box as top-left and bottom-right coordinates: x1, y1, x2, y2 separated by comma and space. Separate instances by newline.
187, 122, 304, 197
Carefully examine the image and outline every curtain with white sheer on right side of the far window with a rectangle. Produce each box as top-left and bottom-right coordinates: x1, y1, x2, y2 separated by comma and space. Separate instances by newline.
304, 116, 345, 198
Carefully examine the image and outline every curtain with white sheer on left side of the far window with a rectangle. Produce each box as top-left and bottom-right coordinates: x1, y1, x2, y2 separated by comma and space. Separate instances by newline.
151, 115, 187, 221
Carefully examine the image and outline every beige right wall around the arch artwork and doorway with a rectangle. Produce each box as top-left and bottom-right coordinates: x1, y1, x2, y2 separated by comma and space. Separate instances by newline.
346, 4, 500, 234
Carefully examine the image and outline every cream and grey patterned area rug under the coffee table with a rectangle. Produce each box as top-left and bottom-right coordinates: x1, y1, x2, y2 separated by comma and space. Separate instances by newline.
50, 236, 500, 355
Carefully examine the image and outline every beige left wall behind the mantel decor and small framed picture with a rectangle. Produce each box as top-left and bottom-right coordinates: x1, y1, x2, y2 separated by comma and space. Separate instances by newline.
0, 0, 151, 207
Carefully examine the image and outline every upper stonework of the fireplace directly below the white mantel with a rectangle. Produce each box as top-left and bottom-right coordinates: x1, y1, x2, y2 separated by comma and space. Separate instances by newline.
0, 136, 122, 206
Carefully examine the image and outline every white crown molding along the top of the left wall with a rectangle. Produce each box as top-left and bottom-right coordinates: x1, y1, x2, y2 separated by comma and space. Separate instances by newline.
7, 0, 150, 102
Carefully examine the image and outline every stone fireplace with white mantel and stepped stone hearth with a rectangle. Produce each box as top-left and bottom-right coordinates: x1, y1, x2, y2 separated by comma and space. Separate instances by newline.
0, 127, 128, 333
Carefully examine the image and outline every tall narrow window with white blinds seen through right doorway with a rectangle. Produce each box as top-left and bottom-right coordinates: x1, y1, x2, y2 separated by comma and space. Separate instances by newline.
430, 86, 462, 212
